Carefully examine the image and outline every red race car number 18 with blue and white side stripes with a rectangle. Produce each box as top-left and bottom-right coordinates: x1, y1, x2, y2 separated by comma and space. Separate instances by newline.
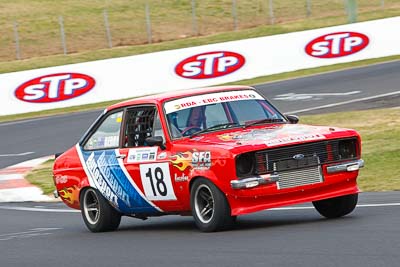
53, 86, 364, 232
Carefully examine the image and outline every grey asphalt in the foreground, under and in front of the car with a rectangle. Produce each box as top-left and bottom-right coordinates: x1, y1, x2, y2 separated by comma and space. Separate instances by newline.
0, 192, 400, 267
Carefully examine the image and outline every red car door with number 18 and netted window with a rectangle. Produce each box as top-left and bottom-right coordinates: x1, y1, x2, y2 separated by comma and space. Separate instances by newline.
119, 105, 181, 212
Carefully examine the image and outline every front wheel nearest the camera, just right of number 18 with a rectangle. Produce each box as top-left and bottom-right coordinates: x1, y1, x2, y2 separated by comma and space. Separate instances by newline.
190, 178, 236, 232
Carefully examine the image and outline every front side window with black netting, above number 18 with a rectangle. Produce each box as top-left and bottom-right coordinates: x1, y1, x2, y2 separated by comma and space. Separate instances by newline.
124, 106, 157, 147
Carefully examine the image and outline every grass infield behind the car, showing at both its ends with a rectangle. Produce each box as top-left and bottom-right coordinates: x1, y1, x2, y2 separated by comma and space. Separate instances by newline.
27, 108, 400, 193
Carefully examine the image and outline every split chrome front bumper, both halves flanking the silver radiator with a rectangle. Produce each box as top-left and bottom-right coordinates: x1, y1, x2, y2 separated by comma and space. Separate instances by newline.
231, 159, 364, 189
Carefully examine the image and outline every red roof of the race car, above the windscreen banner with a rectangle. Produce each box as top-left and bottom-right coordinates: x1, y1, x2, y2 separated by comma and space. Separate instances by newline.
107, 85, 254, 111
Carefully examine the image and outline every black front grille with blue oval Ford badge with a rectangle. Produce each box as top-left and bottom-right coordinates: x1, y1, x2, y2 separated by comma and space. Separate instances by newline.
255, 138, 357, 174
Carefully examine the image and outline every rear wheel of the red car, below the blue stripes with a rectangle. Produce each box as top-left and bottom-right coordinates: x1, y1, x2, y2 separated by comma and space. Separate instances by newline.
80, 187, 121, 233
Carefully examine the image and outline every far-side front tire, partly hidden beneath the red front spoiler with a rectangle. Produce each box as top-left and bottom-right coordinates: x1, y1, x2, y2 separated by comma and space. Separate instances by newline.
313, 194, 358, 219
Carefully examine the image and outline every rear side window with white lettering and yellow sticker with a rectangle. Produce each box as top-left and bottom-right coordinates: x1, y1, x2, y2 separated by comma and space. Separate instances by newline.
84, 111, 123, 150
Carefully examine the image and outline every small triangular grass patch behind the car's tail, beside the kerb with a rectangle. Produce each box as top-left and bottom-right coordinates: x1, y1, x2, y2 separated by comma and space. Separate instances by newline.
25, 159, 56, 195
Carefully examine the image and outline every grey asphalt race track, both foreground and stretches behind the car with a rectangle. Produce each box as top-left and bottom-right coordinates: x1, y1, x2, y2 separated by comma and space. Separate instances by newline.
0, 61, 400, 267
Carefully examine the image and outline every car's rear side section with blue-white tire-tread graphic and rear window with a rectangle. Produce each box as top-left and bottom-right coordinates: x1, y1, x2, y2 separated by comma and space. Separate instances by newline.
78, 110, 160, 214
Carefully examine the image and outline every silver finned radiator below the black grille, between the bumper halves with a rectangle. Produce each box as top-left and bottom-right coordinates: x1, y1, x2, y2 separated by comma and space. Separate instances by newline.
277, 166, 323, 189
